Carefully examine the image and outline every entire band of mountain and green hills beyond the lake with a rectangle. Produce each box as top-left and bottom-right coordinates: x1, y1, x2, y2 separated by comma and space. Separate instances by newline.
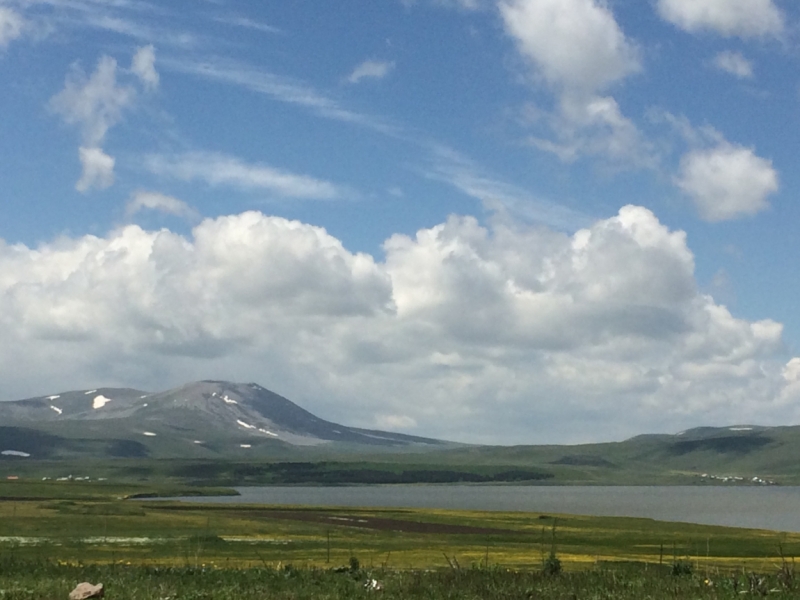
0, 381, 800, 485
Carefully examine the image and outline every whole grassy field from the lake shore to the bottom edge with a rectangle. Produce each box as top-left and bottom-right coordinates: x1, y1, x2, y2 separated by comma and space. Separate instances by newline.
0, 482, 800, 600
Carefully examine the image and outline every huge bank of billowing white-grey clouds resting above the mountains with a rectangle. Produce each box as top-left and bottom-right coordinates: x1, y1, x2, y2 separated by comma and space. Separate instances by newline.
0, 206, 798, 443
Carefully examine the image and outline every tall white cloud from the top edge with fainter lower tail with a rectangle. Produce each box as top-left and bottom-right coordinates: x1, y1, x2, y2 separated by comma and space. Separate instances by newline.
499, 0, 652, 166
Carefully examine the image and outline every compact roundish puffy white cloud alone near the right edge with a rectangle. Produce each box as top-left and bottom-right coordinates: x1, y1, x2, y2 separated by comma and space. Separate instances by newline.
676, 141, 779, 221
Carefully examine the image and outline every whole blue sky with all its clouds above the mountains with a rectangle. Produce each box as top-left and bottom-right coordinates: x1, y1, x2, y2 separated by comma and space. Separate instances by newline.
0, 0, 800, 444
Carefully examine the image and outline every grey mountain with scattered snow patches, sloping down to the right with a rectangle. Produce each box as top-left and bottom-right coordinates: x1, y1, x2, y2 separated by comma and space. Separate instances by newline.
0, 381, 453, 459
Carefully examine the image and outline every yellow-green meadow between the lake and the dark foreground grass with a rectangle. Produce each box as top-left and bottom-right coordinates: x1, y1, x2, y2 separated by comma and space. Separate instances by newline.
0, 482, 800, 571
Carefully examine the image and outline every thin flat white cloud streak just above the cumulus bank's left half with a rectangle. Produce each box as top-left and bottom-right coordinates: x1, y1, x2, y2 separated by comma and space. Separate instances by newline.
144, 152, 345, 200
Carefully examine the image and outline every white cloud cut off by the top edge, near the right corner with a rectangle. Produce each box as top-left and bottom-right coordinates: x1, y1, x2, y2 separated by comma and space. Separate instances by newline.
657, 0, 785, 38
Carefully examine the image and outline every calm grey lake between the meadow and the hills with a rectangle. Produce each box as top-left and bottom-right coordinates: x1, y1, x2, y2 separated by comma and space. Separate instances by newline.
166, 485, 800, 532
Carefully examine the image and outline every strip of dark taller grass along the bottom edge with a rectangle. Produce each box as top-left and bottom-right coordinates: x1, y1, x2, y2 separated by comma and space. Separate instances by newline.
0, 558, 800, 600
